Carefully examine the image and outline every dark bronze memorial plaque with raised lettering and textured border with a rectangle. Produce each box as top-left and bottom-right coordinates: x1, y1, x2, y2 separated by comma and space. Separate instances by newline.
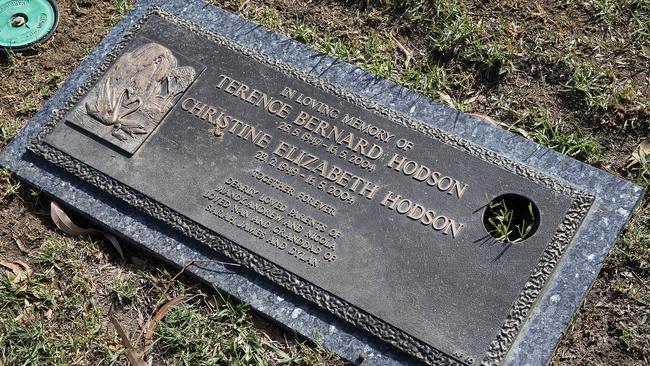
29, 10, 592, 365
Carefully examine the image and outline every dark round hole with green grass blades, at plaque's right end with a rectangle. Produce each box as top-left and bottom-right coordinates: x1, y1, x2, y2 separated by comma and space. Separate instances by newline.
483, 193, 540, 244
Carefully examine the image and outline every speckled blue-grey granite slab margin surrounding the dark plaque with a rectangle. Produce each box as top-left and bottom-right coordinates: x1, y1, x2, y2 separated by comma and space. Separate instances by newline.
0, 0, 643, 366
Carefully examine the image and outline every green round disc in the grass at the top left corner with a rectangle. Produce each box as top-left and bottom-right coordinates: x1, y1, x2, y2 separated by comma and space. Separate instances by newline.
0, 0, 59, 51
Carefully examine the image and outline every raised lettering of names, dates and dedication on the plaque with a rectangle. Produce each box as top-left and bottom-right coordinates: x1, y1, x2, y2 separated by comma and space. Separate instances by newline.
180, 74, 469, 244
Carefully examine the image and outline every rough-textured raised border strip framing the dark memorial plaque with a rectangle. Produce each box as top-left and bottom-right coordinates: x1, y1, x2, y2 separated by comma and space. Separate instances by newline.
28, 7, 594, 366
